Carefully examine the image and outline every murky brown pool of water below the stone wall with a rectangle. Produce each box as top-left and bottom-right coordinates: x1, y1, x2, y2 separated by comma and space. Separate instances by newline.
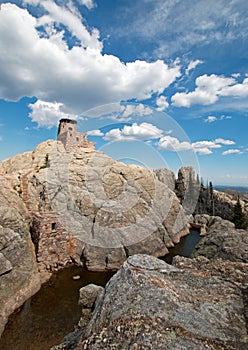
0, 266, 113, 350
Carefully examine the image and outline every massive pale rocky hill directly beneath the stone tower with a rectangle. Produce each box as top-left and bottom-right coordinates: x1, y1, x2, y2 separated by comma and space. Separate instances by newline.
2, 141, 188, 271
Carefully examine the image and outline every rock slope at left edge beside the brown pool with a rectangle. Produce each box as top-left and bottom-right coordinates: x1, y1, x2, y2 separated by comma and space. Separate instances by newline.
0, 176, 40, 335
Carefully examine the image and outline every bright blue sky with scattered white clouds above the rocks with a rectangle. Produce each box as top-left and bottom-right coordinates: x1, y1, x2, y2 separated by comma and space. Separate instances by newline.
0, 0, 248, 186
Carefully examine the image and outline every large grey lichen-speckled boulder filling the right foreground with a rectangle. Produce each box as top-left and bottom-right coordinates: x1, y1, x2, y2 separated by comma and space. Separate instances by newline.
59, 255, 248, 350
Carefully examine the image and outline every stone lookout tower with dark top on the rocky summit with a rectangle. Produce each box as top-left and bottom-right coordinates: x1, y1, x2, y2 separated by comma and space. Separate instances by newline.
57, 119, 95, 152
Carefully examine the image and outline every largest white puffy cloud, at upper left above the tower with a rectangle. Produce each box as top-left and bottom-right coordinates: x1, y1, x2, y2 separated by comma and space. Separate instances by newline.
0, 0, 181, 125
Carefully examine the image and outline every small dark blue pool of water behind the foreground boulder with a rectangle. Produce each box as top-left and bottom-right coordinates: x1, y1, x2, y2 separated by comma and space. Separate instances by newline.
162, 230, 202, 264
